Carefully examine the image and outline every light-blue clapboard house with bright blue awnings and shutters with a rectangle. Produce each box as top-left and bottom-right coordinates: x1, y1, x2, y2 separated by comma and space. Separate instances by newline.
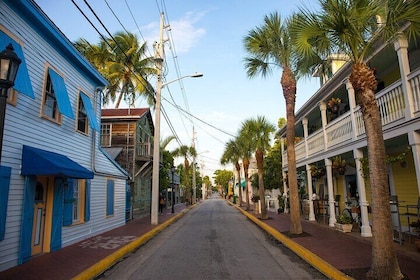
0, 0, 128, 271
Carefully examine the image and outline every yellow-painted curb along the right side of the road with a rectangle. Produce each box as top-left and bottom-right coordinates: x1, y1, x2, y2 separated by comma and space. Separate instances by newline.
228, 201, 353, 280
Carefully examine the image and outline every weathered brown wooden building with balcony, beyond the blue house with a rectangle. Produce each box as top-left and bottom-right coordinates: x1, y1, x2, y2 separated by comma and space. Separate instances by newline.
101, 108, 154, 218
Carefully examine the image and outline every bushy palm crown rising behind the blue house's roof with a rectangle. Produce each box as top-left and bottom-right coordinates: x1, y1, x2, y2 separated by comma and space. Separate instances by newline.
75, 32, 157, 108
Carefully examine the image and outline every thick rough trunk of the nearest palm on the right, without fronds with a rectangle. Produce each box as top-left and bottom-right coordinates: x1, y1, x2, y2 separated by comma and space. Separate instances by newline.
350, 63, 403, 279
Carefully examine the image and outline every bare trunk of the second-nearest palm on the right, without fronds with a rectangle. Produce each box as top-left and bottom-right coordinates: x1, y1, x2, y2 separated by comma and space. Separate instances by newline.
281, 67, 303, 234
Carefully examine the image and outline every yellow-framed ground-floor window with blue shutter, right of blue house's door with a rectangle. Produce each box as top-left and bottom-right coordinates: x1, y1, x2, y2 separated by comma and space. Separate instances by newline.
63, 179, 90, 226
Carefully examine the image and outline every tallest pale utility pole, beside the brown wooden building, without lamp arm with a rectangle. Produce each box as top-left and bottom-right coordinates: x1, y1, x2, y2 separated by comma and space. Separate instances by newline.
150, 13, 164, 225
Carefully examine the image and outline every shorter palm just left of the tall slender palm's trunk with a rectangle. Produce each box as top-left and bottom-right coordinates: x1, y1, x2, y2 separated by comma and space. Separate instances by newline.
243, 116, 275, 219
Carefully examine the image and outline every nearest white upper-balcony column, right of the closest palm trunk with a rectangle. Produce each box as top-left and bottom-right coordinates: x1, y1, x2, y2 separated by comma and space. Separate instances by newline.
394, 34, 414, 120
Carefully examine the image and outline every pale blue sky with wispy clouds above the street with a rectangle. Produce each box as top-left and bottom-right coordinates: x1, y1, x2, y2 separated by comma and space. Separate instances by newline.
35, 0, 319, 178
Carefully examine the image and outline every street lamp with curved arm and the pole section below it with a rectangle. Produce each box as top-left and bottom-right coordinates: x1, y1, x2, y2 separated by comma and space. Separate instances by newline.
150, 72, 203, 225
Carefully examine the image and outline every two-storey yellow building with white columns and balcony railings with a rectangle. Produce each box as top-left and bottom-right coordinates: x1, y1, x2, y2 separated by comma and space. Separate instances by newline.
277, 27, 420, 241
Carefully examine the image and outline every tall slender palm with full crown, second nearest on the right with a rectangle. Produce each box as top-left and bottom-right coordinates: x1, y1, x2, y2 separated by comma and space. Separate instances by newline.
244, 13, 302, 234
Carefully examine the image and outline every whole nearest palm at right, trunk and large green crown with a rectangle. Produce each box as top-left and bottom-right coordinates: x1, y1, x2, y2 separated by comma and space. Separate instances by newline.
289, 0, 420, 279
